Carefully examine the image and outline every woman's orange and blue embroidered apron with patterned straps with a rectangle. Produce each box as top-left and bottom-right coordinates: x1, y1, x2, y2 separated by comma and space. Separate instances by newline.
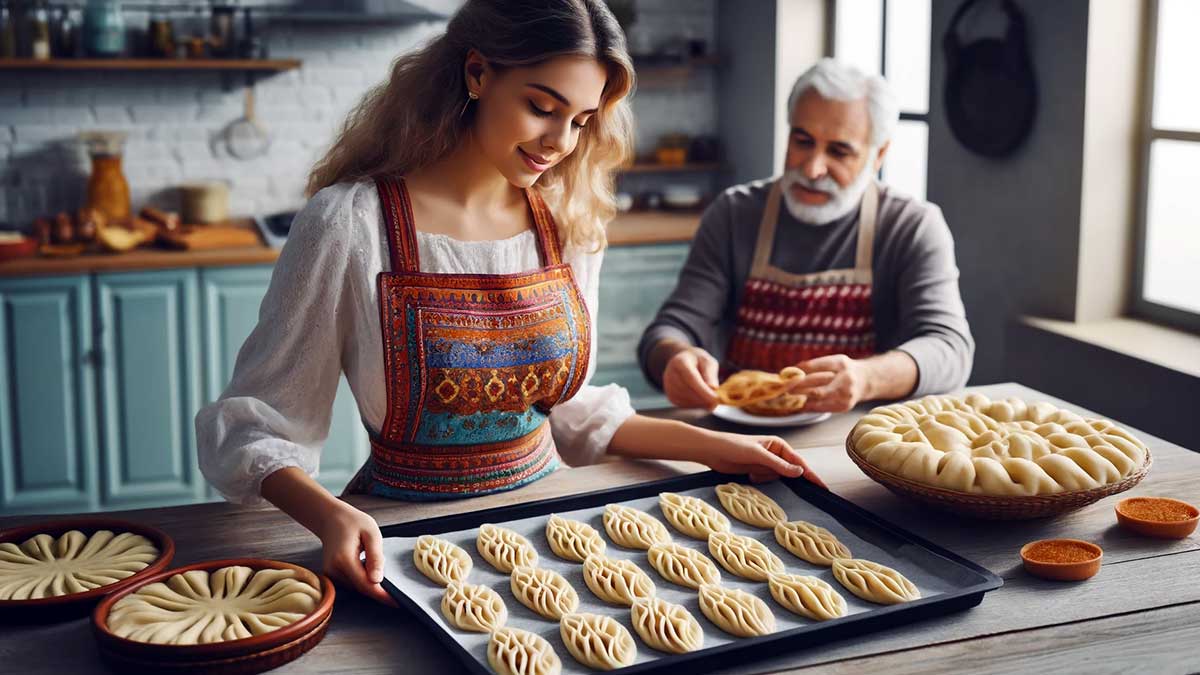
346, 179, 592, 501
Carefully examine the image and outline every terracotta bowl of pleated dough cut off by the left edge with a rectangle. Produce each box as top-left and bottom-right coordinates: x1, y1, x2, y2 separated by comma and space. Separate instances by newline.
0, 516, 175, 623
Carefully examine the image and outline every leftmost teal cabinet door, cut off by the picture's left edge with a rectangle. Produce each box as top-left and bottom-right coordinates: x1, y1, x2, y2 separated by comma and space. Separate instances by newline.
0, 276, 98, 515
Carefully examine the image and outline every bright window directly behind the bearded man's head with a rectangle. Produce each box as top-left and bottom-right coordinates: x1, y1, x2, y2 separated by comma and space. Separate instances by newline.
832, 0, 931, 199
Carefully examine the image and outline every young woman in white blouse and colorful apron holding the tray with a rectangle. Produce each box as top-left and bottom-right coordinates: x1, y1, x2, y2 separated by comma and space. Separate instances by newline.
196, 0, 815, 602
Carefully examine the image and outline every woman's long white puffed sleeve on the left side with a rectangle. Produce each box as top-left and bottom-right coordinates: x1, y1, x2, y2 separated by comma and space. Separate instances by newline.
196, 185, 356, 504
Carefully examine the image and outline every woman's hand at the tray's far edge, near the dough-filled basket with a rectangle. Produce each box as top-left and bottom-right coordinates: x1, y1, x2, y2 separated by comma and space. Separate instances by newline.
691, 431, 828, 489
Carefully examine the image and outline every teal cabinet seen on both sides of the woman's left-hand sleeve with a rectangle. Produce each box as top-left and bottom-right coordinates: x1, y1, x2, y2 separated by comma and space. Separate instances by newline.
200, 265, 370, 495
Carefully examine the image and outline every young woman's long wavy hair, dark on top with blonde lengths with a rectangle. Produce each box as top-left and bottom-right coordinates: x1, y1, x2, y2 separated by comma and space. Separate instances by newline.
306, 0, 635, 249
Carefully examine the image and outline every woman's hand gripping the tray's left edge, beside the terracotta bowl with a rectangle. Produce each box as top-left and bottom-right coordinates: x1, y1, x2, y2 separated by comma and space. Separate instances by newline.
314, 501, 396, 607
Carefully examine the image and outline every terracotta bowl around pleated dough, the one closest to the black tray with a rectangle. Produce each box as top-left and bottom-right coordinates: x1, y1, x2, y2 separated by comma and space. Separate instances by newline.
91, 557, 335, 674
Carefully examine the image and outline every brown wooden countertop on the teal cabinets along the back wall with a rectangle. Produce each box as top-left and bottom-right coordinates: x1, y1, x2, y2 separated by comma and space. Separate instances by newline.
0, 211, 700, 279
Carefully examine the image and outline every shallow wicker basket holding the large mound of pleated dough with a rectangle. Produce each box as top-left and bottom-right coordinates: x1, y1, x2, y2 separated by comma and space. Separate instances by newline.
846, 436, 1152, 520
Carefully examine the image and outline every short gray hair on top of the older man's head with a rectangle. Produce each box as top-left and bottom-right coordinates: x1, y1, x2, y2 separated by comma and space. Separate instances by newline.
787, 58, 900, 148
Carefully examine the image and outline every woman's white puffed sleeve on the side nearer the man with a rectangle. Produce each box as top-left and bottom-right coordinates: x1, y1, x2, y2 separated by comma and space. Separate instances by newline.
550, 243, 634, 466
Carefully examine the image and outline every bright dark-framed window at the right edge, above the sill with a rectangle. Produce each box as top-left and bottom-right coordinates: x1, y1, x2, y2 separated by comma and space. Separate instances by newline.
1134, 0, 1200, 330
